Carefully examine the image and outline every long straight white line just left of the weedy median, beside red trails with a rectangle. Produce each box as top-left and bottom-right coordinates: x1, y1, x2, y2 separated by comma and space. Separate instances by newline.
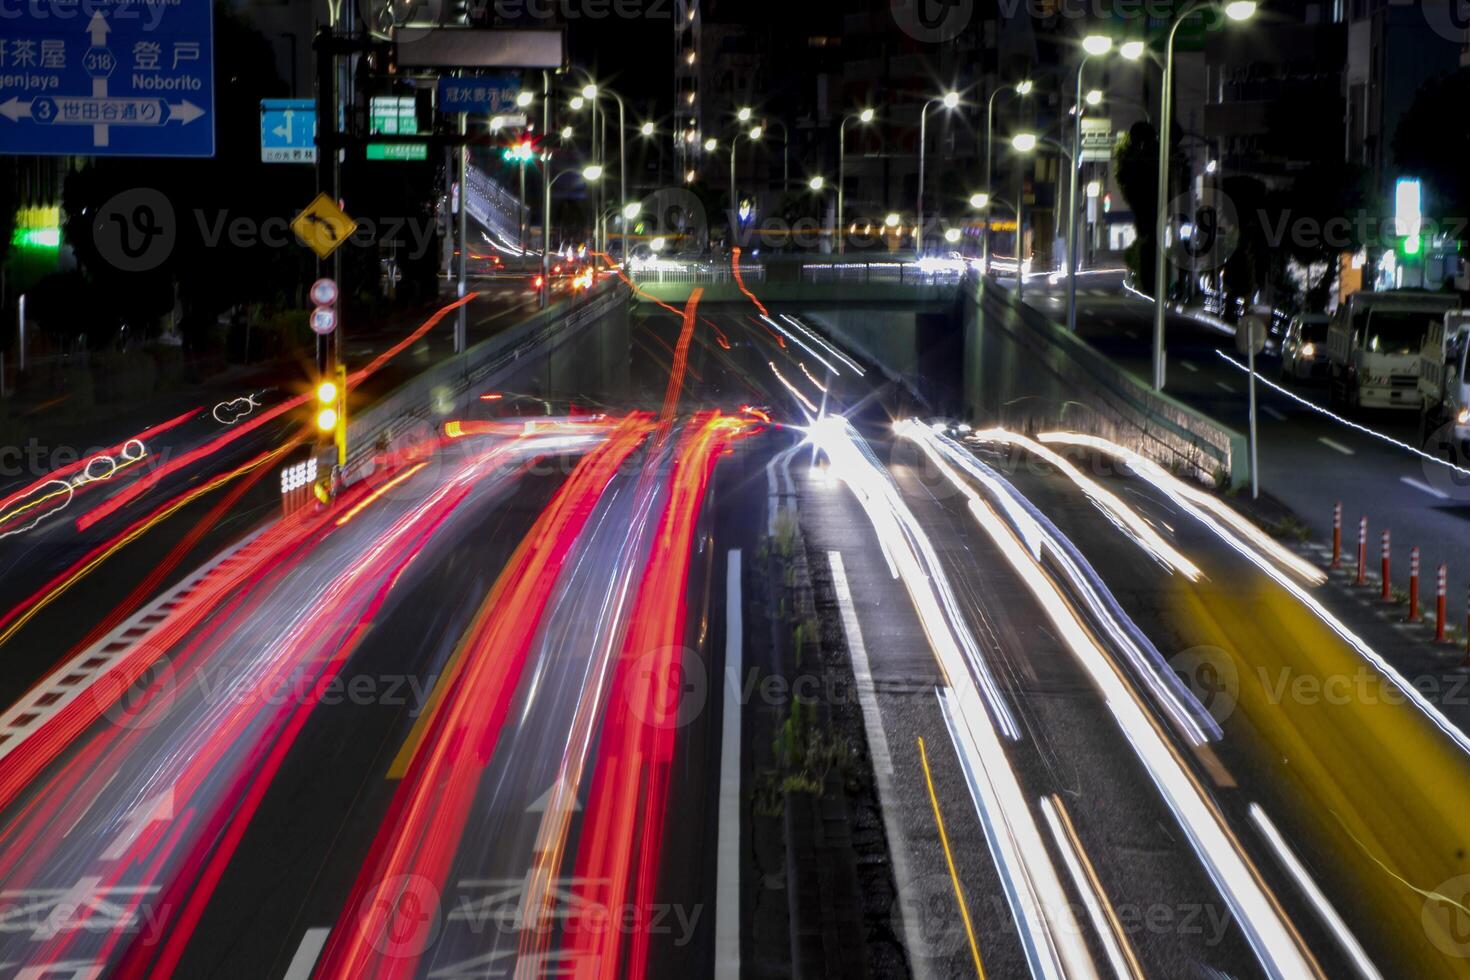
714, 548, 745, 980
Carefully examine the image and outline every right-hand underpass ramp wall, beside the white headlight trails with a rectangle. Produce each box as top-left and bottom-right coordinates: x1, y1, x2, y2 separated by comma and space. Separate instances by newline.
963, 275, 1250, 486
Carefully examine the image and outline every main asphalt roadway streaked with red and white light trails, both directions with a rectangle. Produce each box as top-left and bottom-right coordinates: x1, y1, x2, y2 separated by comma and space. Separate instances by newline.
0, 277, 1470, 979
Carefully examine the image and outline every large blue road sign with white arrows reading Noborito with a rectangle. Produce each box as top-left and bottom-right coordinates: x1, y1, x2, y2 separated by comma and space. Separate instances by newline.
0, 0, 215, 157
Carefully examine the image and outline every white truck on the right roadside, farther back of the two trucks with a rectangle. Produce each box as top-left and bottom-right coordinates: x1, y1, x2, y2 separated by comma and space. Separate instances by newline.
1327, 289, 1460, 408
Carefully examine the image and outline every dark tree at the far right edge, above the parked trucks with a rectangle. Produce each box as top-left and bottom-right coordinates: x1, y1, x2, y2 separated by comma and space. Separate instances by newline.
1394, 68, 1470, 242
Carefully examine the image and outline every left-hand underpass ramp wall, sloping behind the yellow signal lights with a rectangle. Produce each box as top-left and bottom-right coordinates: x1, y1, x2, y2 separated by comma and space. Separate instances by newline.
341, 279, 628, 483
